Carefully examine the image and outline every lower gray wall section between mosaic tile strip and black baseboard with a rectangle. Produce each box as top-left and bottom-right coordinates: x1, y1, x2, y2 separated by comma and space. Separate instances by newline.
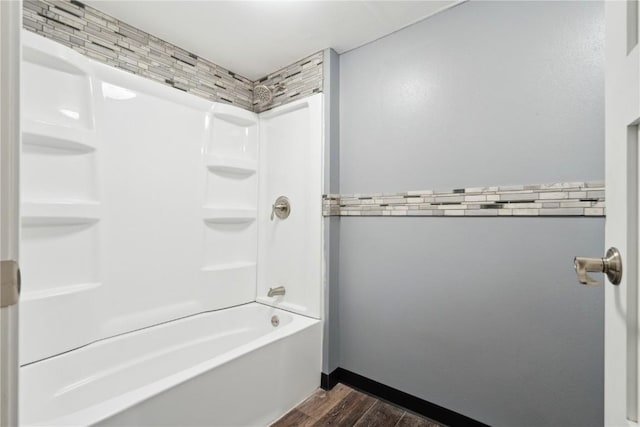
340, 218, 604, 427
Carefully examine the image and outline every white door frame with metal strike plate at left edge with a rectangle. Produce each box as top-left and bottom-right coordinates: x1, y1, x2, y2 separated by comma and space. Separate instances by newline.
0, 0, 22, 427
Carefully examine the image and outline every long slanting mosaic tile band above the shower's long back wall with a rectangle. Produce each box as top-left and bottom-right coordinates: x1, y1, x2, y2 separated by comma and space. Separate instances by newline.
23, 0, 253, 110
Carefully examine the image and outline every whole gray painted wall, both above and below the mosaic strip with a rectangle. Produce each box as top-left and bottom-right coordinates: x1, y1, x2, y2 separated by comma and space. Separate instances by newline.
340, 2, 604, 426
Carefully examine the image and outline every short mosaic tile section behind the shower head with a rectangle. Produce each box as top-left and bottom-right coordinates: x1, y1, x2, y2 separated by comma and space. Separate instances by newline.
253, 51, 324, 113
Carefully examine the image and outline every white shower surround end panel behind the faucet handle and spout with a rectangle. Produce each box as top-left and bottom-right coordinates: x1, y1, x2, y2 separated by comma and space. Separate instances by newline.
257, 95, 324, 318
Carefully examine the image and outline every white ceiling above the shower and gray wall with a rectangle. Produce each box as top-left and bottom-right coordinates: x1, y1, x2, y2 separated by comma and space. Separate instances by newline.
85, 0, 459, 80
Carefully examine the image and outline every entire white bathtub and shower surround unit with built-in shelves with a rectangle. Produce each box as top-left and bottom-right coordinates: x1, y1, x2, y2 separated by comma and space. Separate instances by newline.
20, 32, 323, 426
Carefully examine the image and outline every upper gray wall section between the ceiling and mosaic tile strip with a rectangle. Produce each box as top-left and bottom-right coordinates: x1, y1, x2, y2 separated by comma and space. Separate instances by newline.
340, 1, 604, 193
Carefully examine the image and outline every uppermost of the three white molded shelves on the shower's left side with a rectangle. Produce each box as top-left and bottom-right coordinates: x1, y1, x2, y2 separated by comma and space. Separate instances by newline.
22, 119, 96, 153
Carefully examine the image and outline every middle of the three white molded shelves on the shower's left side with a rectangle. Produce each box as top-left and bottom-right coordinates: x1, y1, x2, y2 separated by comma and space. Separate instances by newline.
20, 201, 100, 226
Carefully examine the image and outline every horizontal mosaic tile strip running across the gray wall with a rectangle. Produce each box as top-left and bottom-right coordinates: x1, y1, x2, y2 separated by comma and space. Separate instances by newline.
323, 182, 605, 217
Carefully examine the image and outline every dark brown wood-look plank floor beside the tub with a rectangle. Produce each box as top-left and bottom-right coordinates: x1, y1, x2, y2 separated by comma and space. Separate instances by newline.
271, 384, 444, 427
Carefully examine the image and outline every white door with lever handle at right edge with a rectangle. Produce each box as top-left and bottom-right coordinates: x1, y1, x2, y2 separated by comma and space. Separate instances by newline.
604, 0, 640, 426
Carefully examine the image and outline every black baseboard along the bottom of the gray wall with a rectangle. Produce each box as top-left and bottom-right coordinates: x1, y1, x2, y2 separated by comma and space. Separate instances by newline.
321, 368, 488, 427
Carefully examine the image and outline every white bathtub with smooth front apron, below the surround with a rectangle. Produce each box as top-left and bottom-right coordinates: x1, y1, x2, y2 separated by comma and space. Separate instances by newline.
20, 303, 321, 426
